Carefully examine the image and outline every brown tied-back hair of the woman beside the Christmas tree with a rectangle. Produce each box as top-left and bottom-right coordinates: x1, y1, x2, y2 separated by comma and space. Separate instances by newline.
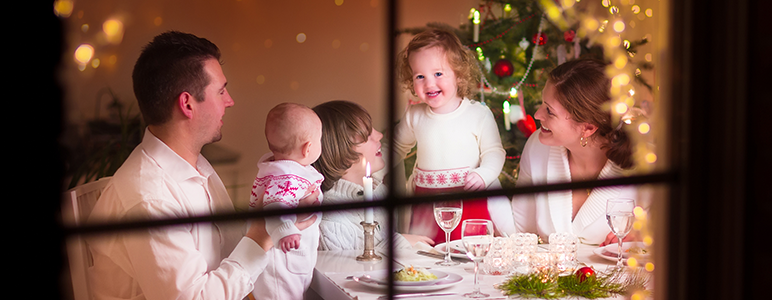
549, 59, 633, 169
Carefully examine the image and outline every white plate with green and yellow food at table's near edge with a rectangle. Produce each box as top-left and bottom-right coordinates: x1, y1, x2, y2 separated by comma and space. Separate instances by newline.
352, 270, 463, 292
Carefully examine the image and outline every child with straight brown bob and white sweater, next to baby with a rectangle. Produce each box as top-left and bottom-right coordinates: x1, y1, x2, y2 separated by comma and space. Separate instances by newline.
313, 101, 433, 250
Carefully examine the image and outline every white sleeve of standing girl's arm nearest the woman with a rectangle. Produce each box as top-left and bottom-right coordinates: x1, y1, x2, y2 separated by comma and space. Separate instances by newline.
472, 108, 506, 186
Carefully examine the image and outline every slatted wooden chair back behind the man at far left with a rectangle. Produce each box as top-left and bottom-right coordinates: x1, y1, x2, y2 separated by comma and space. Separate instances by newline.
62, 177, 110, 300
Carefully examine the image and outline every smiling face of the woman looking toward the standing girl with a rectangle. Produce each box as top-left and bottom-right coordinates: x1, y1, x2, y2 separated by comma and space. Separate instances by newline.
534, 80, 582, 146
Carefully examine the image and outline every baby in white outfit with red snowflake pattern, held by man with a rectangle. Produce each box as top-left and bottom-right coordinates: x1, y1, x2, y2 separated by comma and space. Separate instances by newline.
249, 103, 324, 300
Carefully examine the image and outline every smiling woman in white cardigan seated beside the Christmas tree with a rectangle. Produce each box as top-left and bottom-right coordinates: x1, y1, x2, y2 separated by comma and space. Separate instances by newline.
512, 60, 637, 245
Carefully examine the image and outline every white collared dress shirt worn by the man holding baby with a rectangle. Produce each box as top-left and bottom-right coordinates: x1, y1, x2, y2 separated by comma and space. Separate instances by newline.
87, 130, 267, 300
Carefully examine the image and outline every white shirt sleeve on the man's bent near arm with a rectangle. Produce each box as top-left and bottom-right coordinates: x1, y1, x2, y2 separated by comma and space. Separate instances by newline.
121, 201, 268, 300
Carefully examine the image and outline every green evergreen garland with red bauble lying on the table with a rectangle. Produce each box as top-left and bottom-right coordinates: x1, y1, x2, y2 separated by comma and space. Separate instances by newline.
496, 269, 651, 299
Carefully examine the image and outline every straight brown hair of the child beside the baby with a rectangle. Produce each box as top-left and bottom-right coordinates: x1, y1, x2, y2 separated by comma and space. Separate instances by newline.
313, 100, 373, 191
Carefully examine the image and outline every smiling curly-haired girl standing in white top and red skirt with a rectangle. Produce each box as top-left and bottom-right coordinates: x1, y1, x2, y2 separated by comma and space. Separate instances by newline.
394, 29, 515, 243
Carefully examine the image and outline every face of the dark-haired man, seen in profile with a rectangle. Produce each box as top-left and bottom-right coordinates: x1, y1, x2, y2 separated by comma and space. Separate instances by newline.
196, 58, 234, 144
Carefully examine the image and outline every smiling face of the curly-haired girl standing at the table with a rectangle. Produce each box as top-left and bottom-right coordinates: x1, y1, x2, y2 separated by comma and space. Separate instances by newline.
409, 47, 461, 114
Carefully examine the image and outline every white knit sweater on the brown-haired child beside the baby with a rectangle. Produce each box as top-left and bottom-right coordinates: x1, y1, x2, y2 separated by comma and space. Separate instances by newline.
319, 178, 411, 250
